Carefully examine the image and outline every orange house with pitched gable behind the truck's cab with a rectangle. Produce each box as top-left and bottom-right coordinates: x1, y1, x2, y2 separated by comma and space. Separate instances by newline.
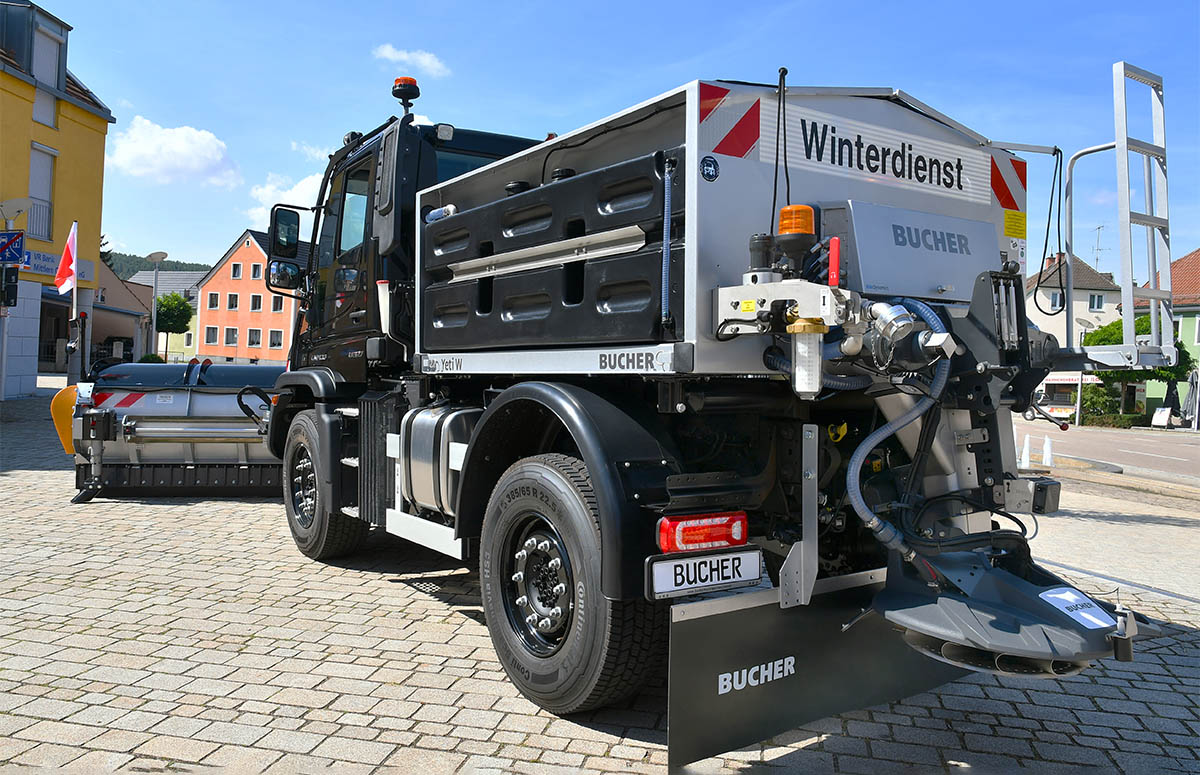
196, 229, 308, 366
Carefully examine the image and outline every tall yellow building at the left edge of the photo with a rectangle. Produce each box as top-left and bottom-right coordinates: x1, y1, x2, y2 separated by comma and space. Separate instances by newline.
0, 0, 114, 397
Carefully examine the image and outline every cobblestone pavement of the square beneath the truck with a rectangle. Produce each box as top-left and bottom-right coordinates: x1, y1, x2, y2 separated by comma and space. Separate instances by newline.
0, 401, 1200, 775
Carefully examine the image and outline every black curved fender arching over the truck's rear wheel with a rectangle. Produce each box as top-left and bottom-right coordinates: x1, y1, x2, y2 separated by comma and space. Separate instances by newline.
456, 382, 677, 600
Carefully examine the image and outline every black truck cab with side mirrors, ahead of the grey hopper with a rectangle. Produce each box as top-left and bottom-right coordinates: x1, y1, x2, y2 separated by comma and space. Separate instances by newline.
269, 99, 536, 389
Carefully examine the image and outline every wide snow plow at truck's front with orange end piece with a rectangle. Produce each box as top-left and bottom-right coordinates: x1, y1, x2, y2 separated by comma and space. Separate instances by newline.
50, 359, 283, 503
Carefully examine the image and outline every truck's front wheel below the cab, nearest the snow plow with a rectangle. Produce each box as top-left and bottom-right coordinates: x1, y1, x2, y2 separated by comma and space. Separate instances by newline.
283, 409, 370, 560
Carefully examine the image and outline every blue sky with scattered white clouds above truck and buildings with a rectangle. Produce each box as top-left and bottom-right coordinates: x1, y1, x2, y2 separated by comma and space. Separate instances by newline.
42, 0, 1200, 280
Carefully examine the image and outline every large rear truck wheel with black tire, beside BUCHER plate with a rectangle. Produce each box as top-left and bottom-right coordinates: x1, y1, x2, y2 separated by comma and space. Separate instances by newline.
479, 455, 667, 714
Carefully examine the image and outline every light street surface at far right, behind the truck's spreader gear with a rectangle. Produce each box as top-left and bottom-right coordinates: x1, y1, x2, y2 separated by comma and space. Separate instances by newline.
1013, 417, 1200, 483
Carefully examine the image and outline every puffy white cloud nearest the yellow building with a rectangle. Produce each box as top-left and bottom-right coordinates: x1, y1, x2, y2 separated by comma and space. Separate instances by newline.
104, 115, 241, 188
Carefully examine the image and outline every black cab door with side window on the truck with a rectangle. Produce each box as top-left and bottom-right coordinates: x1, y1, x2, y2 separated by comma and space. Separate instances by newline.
308, 155, 377, 383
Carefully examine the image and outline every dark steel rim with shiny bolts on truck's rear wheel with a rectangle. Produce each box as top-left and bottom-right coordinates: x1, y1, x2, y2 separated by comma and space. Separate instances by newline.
500, 511, 575, 657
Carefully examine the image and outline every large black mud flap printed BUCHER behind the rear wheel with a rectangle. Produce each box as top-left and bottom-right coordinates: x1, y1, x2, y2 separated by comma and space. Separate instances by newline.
667, 584, 967, 767
